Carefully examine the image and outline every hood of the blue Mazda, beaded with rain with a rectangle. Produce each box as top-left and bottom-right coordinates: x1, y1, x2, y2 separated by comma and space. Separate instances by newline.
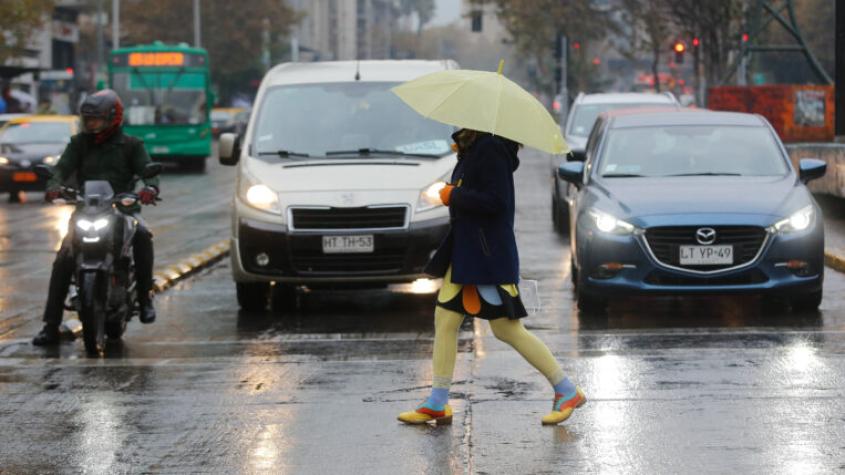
596, 175, 811, 226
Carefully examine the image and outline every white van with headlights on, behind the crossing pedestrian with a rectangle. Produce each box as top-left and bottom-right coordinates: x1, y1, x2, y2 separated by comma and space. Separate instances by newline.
219, 61, 458, 310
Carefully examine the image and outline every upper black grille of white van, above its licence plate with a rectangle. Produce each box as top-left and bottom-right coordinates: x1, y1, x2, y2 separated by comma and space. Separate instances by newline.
291, 206, 408, 231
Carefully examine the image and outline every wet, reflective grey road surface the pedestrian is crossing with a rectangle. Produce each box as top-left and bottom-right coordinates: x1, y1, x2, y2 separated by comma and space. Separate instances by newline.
0, 153, 845, 474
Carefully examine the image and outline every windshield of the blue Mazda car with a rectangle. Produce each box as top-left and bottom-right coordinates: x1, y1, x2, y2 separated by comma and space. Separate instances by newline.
599, 125, 788, 177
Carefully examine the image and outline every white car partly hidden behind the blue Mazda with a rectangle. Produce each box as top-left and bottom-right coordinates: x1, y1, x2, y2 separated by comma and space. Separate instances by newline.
552, 92, 680, 234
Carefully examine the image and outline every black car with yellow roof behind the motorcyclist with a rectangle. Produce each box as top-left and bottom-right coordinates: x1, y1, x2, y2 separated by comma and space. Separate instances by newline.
0, 115, 79, 203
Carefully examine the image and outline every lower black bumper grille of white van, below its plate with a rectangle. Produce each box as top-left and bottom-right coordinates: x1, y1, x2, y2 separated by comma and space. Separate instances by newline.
291, 249, 405, 275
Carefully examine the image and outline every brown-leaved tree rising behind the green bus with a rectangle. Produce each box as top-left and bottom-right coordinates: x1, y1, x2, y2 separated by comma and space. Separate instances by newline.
121, 0, 298, 103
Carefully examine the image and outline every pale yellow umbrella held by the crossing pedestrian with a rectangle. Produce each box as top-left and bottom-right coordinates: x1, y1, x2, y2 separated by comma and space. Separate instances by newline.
392, 61, 569, 153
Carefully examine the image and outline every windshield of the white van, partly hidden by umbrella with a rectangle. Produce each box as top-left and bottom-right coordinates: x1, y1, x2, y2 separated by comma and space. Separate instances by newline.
253, 82, 453, 157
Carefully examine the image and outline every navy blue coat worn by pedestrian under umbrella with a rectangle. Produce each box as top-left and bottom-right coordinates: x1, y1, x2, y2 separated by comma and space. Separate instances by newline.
425, 134, 519, 285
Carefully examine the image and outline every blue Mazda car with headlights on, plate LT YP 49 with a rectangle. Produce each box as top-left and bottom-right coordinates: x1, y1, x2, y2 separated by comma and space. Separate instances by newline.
558, 110, 826, 314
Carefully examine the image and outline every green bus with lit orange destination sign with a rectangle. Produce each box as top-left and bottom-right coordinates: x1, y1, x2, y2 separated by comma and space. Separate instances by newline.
108, 41, 214, 171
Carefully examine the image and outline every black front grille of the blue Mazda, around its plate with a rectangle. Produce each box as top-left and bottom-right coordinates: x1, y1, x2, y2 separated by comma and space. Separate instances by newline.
645, 226, 766, 272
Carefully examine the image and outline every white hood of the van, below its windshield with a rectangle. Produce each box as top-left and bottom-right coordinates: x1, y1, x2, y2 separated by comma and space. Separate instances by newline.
247, 155, 457, 193
